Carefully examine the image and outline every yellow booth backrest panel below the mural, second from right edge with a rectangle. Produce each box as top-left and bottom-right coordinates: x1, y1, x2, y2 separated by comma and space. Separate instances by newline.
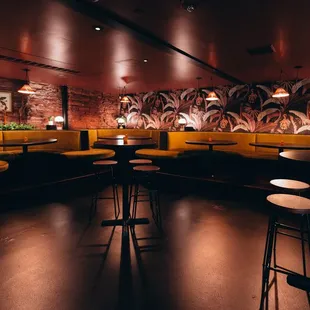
167, 131, 255, 152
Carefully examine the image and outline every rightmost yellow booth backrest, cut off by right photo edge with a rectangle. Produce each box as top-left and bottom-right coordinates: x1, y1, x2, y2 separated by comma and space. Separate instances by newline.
256, 133, 310, 153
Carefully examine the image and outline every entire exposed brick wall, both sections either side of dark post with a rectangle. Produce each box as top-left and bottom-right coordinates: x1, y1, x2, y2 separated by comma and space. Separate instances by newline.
0, 78, 119, 129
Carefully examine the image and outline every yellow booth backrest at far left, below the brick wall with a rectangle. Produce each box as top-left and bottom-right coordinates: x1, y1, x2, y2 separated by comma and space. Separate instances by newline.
2, 130, 80, 152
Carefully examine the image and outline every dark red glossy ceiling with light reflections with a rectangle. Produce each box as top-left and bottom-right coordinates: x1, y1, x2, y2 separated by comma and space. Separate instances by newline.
0, 0, 310, 92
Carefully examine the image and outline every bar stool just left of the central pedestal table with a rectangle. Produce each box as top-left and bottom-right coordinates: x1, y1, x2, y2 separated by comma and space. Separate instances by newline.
89, 160, 120, 221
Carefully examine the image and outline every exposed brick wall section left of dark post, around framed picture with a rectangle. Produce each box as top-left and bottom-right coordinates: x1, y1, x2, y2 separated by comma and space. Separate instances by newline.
0, 78, 62, 129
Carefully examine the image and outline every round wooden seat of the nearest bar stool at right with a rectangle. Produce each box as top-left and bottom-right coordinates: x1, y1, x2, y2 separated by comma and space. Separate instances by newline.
267, 194, 310, 214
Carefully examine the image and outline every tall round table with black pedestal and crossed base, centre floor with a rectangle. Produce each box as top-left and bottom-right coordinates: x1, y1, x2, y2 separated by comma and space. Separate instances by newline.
94, 139, 156, 238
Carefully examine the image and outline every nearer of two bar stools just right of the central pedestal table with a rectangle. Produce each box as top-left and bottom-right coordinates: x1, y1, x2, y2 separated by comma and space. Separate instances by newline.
132, 165, 163, 233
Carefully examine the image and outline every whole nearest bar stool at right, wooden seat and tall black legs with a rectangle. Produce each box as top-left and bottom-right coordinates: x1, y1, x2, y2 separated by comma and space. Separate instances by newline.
260, 193, 310, 310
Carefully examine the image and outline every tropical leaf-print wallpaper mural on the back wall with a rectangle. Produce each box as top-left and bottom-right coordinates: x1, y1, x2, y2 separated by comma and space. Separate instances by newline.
121, 79, 310, 134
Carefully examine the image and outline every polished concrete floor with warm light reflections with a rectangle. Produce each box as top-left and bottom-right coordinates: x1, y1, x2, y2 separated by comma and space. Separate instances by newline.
0, 185, 310, 310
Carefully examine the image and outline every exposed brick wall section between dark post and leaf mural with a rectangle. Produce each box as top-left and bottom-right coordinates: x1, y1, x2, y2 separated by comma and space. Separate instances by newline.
68, 88, 119, 129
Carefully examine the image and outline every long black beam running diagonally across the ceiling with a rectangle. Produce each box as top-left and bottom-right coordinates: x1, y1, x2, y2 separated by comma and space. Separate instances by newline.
56, 0, 245, 84
